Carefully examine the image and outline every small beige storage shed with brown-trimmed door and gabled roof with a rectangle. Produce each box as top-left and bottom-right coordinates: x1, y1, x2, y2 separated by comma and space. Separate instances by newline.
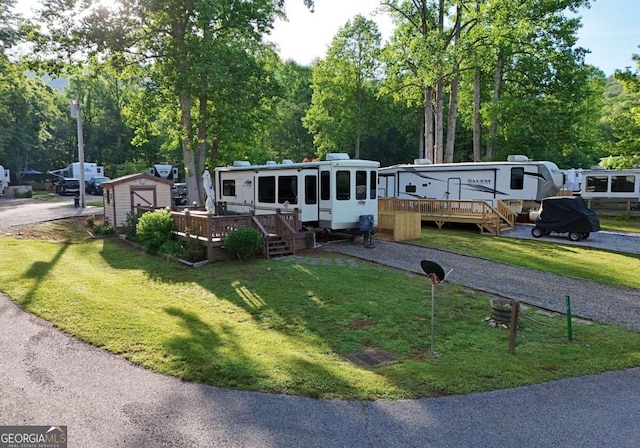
102, 173, 172, 228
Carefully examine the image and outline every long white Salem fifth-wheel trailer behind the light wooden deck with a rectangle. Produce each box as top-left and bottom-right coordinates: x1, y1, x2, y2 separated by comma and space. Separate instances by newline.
378, 156, 563, 210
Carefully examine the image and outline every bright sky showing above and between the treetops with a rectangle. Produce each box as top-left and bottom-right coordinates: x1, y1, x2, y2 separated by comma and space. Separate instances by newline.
12, 0, 640, 75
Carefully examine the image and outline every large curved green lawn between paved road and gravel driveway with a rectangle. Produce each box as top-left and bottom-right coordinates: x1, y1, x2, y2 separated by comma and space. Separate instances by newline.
0, 218, 640, 399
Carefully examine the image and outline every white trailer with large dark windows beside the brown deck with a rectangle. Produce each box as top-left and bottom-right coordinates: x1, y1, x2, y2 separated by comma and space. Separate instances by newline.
214, 154, 380, 232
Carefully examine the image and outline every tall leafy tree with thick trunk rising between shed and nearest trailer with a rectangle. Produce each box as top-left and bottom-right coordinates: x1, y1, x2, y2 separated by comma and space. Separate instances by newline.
33, 0, 313, 202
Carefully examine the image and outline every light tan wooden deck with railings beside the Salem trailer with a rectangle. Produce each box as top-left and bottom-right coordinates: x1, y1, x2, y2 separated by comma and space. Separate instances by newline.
378, 198, 516, 235
